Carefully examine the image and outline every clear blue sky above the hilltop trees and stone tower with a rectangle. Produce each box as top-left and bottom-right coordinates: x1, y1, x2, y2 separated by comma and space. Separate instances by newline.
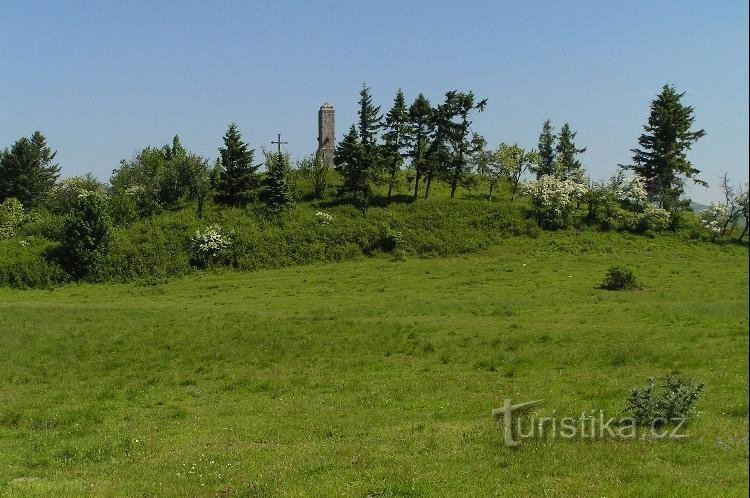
0, 0, 748, 202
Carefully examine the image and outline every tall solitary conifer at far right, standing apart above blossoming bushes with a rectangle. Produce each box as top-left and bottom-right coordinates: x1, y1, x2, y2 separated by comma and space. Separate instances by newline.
625, 85, 706, 210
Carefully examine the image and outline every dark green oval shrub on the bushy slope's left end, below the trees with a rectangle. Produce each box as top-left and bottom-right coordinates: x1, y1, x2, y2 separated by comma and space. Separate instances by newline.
60, 194, 112, 279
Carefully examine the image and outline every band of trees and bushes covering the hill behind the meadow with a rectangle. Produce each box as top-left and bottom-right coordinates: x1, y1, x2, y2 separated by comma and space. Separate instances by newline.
0, 85, 748, 286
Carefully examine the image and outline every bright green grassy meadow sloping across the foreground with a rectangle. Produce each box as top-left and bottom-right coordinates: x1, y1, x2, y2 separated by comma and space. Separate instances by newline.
0, 233, 748, 497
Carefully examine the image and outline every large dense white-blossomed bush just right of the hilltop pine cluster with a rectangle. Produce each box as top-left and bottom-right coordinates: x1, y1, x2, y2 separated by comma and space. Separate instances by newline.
522, 175, 588, 226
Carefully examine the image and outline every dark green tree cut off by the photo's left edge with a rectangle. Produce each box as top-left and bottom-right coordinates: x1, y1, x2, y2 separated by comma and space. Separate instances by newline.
0, 131, 60, 208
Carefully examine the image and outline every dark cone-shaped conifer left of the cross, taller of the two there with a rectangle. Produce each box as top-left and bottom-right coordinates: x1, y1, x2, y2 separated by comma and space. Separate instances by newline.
217, 123, 258, 206
